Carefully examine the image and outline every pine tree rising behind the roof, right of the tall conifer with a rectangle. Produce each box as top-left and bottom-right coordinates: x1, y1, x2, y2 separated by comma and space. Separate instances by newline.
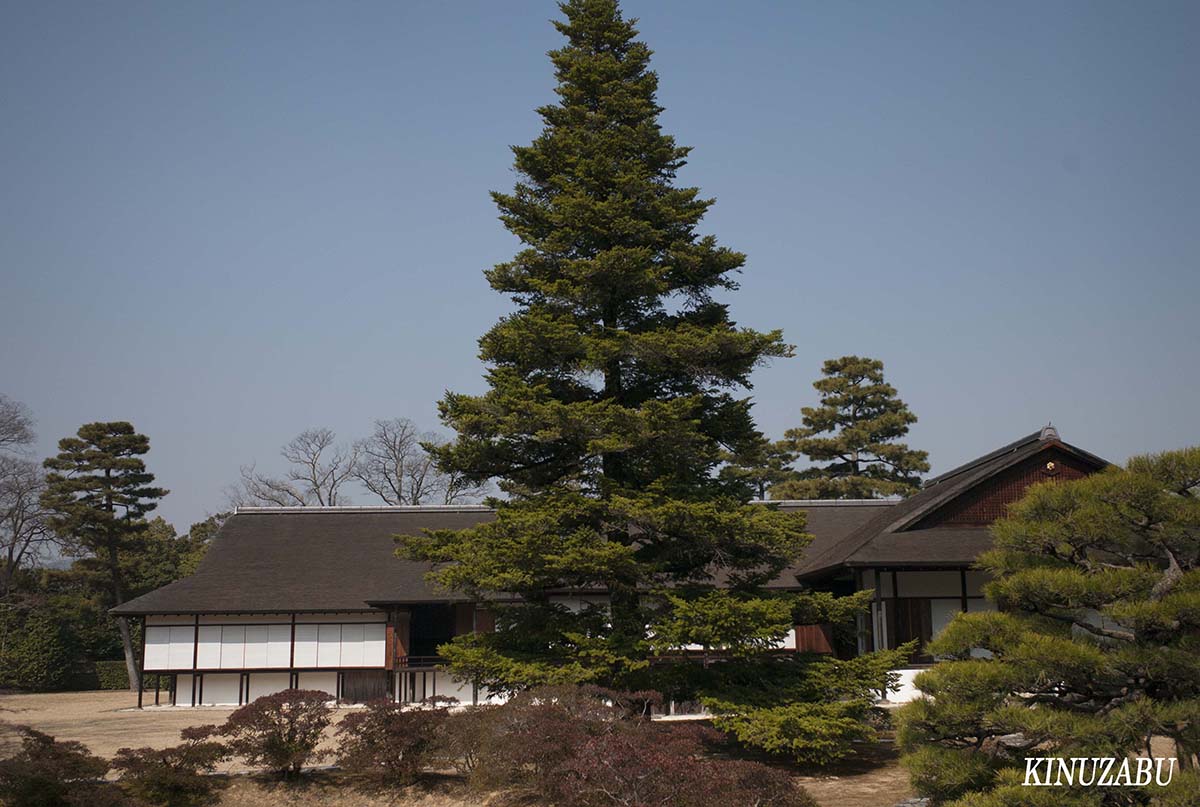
770, 355, 929, 498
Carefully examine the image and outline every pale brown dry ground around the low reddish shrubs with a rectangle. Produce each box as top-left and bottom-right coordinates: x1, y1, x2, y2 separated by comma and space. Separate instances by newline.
0, 692, 912, 807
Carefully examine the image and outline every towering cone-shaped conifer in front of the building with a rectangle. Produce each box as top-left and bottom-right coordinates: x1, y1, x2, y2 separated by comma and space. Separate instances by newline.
400, 0, 902, 763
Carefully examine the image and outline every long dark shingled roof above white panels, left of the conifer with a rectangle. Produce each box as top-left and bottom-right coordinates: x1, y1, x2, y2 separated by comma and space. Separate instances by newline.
113, 507, 493, 614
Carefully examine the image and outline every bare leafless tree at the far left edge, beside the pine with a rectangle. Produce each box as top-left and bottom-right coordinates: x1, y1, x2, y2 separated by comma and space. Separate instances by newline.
0, 455, 55, 596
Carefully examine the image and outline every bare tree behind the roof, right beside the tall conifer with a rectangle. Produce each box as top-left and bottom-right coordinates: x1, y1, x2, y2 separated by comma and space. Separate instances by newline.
354, 418, 482, 504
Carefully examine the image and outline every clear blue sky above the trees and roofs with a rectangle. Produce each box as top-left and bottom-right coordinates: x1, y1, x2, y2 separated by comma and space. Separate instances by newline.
0, 0, 1200, 528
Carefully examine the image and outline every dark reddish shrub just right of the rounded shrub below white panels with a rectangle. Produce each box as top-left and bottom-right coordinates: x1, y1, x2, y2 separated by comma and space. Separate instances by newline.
337, 700, 448, 787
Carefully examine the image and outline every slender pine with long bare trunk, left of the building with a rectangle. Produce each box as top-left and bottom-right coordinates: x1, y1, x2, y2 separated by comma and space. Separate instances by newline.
42, 422, 167, 691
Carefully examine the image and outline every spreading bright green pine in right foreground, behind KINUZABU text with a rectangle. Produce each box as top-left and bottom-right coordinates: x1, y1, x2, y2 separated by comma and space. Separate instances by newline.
900, 448, 1200, 807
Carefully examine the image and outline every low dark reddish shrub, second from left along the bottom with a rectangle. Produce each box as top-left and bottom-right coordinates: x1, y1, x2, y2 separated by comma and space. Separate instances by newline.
113, 725, 229, 807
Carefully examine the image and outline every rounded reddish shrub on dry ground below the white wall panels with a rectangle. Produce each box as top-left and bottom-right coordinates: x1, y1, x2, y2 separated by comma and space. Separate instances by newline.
221, 689, 334, 778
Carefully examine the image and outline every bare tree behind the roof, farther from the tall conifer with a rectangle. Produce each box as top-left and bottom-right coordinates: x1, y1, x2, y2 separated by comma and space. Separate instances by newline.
227, 429, 358, 507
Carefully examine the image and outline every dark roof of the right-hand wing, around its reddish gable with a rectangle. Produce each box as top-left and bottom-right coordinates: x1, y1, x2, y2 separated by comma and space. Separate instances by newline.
797, 425, 1108, 579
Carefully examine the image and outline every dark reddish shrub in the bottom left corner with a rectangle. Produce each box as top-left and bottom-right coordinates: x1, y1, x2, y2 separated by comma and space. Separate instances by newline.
0, 725, 120, 807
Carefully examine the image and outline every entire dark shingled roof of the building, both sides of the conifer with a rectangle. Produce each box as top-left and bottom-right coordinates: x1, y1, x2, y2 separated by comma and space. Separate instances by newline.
113, 428, 1106, 615
